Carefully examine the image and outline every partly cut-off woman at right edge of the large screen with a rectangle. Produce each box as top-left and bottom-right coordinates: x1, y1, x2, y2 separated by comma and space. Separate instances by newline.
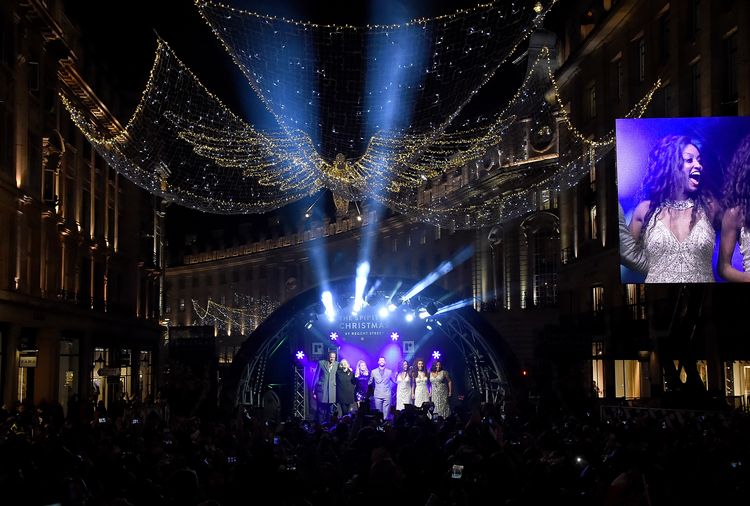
717, 135, 750, 282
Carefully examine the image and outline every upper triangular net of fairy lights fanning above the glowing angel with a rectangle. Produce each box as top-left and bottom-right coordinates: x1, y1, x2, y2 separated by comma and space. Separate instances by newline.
195, 0, 557, 162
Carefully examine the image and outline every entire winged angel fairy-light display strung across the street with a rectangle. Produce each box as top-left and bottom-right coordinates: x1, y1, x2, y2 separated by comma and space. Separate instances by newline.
62, 0, 660, 228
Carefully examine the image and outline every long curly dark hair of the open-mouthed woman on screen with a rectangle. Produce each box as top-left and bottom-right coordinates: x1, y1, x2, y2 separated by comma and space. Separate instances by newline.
638, 135, 706, 241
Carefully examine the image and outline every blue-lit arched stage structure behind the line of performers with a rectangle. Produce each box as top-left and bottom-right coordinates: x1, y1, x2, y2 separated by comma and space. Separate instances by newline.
220, 277, 519, 418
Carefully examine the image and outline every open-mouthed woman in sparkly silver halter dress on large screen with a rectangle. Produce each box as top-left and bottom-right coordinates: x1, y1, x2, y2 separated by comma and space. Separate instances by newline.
630, 135, 718, 283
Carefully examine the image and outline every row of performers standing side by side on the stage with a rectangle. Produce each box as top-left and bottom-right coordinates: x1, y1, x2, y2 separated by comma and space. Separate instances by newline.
313, 351, 453, 421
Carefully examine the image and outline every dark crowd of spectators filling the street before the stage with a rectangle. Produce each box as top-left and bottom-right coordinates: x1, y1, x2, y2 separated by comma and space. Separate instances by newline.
0, 401, 750, 506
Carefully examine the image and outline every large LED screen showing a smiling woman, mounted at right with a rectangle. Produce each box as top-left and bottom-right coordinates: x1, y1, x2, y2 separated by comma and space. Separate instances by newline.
616, 117, 750, 283
